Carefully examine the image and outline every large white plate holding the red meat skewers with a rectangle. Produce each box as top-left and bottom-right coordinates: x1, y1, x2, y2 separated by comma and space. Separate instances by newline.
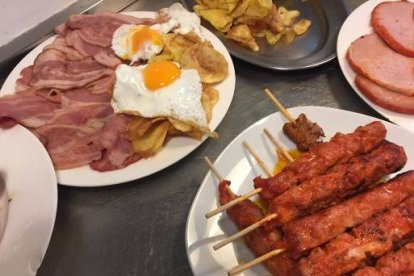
185, 106, 414, 276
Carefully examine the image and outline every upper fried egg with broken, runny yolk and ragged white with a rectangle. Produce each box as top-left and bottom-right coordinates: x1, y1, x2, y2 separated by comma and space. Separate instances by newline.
112, 3, 202, 61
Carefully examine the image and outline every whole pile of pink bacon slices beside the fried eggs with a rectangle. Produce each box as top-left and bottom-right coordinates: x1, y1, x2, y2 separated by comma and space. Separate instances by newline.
0, 12, 154, 171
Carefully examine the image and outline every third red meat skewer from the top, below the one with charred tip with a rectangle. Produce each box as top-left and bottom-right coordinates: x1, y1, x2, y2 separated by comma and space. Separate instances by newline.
283, 171, 414, 258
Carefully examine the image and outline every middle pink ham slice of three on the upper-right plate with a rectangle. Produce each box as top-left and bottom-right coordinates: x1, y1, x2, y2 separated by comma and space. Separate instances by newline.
347, 33, 414, 96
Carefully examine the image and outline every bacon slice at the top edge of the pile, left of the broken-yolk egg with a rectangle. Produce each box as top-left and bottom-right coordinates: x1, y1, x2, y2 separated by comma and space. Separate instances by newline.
66, 12, 155, 47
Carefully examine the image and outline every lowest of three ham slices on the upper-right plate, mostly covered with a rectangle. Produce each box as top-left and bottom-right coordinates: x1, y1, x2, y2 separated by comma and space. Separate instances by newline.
355, 75, 414, 114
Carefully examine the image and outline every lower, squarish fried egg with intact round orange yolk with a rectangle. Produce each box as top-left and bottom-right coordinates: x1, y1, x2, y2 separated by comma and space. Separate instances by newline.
111, 61, 208, 128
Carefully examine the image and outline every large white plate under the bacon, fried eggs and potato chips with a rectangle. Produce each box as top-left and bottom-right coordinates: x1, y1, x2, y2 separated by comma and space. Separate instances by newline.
0, 11, 236, 187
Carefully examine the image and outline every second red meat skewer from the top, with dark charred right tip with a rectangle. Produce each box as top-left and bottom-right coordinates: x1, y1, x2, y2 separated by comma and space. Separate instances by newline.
268, 141, 407, 225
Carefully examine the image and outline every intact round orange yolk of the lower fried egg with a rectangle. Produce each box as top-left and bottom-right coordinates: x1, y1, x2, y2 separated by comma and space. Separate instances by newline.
143, 61, 181, 90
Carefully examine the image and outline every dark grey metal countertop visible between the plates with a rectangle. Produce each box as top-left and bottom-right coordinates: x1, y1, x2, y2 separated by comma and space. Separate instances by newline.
0, 0, 384, 276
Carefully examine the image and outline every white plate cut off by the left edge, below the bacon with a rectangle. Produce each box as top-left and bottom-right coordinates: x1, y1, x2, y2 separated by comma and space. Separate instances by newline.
0, 125, 57, 275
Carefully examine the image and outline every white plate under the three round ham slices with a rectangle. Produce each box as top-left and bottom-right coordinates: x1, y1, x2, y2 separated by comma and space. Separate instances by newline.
336, 0, 414, 132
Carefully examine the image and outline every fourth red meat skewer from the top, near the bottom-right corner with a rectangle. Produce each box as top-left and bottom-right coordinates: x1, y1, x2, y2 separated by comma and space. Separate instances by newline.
299, 197, 414, 276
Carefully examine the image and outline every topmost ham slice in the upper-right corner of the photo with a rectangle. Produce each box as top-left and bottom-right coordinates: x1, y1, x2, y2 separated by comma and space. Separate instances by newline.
371, 1, 414, 57
